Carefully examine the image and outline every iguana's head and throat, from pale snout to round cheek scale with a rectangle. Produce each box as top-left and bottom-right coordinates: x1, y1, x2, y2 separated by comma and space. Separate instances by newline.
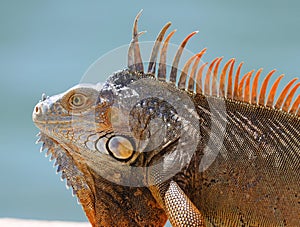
33, 79, 173, 226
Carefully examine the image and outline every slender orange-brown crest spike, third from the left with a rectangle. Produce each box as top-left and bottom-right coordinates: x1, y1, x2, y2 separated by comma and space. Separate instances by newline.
157, 30, 176, 81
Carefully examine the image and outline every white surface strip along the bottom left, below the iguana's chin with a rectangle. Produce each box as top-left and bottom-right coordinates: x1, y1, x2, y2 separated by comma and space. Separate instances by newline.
0, 218, 91, 227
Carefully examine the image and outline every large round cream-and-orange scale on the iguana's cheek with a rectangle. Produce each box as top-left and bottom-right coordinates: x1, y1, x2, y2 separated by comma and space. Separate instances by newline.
107, 136, 134, 161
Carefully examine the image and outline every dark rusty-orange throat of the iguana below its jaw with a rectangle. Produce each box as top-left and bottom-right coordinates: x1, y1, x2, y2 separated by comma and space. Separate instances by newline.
86, 167, 167, 226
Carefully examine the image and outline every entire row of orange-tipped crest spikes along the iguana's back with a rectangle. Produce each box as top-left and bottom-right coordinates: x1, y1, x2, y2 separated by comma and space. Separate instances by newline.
128, 13, 300, 116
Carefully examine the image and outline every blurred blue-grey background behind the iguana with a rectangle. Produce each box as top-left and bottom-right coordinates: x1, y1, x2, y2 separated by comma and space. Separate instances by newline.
0, 0, 300, 225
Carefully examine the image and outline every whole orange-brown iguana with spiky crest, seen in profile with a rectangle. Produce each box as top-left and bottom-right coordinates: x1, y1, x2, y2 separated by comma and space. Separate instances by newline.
33, 11, 300, 226
